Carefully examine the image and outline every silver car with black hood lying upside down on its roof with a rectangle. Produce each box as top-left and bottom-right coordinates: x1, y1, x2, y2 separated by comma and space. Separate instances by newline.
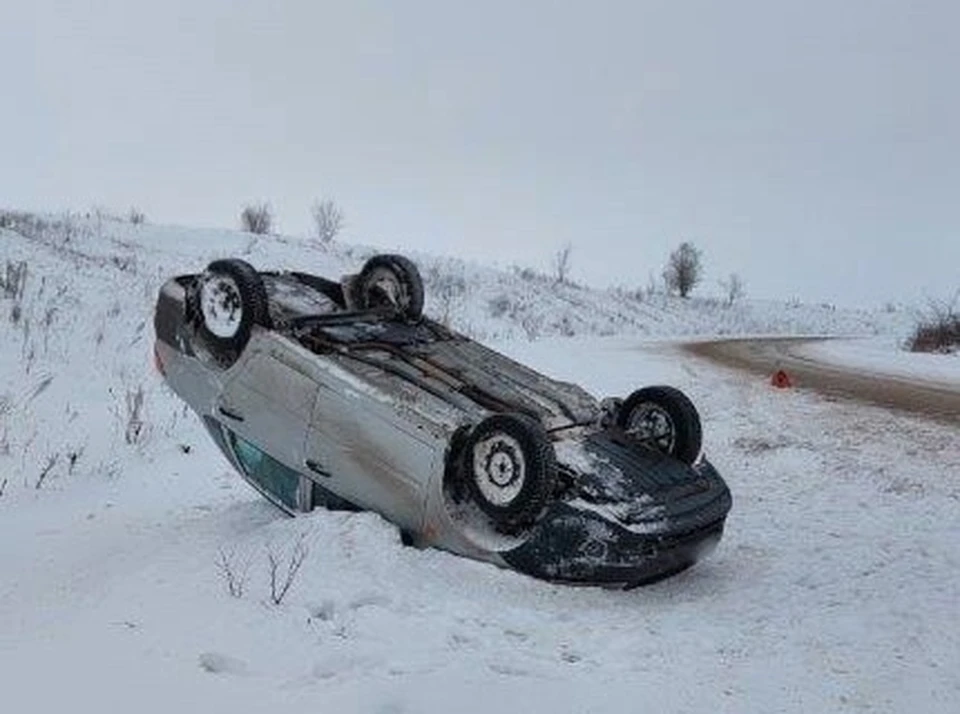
155, 255, 731, 587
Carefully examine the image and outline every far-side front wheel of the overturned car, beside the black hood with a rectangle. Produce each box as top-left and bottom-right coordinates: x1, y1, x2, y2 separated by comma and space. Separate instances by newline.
617, 386, 703, 464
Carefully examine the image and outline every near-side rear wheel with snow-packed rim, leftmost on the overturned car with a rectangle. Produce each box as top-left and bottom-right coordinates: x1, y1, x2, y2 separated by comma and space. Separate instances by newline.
194, 258, 270, 365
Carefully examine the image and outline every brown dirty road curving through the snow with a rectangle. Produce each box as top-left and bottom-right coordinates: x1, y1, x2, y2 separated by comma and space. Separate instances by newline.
684, 338, 960, 425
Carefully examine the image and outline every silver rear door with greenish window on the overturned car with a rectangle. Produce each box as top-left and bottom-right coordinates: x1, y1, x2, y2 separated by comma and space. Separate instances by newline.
216, 344, 317, 511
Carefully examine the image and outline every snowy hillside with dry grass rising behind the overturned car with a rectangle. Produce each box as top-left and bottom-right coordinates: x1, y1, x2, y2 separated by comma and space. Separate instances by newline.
0, 212, 908, 498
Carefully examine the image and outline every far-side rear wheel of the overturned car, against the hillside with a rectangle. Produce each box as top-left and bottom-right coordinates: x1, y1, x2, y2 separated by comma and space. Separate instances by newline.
354, 250, 423, 321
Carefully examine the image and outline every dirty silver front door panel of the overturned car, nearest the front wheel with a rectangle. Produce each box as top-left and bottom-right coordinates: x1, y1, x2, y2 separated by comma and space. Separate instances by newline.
304, 358, 442, 530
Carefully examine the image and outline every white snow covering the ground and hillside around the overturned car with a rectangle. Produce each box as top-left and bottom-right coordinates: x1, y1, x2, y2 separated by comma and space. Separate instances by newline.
0, 214, 960, 714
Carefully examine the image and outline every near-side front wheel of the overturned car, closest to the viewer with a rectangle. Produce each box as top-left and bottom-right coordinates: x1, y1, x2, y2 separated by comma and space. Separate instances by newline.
459, 414, 557, 532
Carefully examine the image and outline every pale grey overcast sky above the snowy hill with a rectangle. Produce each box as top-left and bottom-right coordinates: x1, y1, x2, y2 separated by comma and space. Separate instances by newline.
0, 0, 960, 305
